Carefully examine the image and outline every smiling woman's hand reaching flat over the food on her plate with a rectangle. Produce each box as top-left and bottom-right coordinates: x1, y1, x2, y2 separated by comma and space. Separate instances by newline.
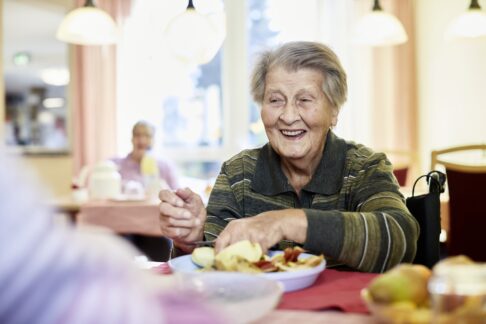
215, 209, 307, 253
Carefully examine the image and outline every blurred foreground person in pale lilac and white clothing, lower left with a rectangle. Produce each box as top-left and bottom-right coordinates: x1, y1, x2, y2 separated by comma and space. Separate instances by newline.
0, 152, 221, 324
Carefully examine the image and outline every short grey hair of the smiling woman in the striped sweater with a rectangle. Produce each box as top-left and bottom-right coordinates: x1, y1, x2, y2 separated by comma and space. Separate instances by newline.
250, 41, 348, 110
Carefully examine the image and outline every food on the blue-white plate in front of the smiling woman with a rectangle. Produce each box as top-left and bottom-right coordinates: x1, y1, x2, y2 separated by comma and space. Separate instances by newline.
191, 240, 324, 273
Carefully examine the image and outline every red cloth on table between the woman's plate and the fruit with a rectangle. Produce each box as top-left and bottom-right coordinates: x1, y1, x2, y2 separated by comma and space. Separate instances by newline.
278, 269, 377, 314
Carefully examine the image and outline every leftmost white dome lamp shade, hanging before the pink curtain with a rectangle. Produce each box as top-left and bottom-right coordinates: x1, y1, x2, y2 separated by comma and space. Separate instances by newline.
56, 2, 118, 45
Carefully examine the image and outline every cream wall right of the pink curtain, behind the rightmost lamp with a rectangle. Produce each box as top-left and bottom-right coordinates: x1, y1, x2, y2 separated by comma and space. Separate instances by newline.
415, 0, 486, 170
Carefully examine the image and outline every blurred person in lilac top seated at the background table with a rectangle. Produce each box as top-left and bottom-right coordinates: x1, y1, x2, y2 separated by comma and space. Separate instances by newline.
112, 120, 179, 261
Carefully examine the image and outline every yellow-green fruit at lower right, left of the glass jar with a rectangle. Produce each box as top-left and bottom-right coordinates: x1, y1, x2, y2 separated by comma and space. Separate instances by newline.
368, 263, 431, 306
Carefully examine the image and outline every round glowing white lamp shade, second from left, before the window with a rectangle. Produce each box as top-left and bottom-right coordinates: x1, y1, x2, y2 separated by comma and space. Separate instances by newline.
165, 6, 226, 65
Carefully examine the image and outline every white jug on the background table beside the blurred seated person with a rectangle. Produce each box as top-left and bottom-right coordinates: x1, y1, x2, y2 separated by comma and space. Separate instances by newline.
88, 161, 122, 199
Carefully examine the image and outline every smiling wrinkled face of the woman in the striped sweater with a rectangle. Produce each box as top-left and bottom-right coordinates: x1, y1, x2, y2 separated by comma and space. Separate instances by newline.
261, 66, 337, 166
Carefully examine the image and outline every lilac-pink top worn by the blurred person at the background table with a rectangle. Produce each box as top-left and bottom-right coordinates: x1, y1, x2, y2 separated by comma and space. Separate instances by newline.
112, 154, 179, 189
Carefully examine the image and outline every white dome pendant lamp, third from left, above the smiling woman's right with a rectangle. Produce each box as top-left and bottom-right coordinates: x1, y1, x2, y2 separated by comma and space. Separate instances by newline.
354, 0, 408, 46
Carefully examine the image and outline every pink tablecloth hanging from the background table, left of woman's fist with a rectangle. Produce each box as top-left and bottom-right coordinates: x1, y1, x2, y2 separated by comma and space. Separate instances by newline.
77, 200, 162, 236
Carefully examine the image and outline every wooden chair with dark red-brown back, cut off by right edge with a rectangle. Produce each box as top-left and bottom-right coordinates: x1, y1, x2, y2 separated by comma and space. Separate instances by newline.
431, 144, 486, 262
